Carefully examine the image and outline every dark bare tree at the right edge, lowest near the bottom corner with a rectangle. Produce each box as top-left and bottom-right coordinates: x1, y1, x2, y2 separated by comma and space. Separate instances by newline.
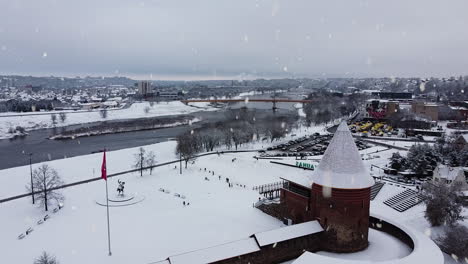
436, 225, 468, 260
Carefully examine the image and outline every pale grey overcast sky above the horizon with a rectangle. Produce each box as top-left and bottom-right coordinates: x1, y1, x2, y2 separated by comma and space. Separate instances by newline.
0, 0, 468, 79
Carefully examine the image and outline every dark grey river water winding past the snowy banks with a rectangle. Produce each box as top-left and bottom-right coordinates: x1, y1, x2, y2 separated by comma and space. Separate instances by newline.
0, 97, 295, 169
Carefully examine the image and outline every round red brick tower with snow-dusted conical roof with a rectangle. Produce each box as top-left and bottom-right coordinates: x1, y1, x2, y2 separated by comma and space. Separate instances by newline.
309, 122, 374, 252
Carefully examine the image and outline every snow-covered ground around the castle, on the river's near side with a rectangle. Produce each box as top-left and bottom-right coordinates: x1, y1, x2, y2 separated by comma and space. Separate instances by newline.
0, 124, 467, 264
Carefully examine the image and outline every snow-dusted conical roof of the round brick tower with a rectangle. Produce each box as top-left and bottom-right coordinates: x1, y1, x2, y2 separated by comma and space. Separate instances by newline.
313, 122, 374, 189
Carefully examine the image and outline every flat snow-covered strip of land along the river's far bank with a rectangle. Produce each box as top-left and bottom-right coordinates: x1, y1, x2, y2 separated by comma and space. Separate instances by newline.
0, 101, 216, 139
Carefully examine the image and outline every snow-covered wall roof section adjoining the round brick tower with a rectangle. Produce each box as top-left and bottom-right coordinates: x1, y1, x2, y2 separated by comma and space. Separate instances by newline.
254, 221, 323, 247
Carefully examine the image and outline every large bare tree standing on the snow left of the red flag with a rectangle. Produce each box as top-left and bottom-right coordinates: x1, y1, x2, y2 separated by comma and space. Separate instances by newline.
26, 164, 64, 211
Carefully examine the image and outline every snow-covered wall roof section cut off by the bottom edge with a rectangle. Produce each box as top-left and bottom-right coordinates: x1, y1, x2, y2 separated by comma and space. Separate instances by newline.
169, 237, 260, 264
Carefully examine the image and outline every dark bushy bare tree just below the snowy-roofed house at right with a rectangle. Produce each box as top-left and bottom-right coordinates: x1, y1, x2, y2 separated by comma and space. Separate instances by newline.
422, 181, 465, 226
